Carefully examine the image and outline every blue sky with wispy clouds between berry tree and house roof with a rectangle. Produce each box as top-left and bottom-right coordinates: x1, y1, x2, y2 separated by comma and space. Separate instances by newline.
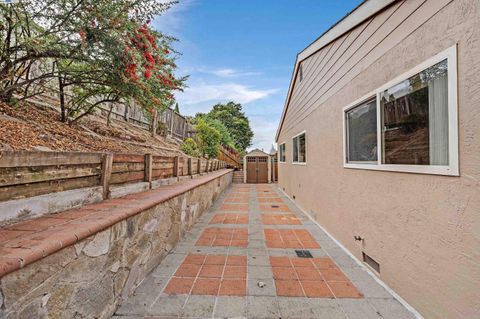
153, 0, 362, 151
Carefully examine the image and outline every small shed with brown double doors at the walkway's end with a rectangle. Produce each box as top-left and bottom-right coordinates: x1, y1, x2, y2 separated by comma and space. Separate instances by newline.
243, 149, 272, 183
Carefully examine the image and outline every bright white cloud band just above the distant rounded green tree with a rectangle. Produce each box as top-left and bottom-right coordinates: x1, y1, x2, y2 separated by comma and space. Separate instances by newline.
176, 83, 278, 104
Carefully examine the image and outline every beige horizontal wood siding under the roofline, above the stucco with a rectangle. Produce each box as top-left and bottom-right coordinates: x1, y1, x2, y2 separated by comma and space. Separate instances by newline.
279, 0, 452, 136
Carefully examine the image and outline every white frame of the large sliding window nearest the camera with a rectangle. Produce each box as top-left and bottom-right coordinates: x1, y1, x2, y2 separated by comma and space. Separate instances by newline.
342, 45, 460, 176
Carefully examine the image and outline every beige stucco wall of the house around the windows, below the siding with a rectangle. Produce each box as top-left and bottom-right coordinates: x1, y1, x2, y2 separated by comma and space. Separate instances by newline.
277, 0, 480, 318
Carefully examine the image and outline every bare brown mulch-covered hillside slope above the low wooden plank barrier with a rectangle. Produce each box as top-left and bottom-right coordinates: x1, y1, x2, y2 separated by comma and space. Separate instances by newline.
0, 103, 181, 155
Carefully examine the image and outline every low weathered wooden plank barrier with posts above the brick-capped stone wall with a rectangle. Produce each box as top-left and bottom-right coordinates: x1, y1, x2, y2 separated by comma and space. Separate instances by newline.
0, 151, 227, 201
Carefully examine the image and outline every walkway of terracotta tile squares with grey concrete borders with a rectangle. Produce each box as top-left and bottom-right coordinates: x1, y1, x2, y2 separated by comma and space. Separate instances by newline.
114, 184, 414, 319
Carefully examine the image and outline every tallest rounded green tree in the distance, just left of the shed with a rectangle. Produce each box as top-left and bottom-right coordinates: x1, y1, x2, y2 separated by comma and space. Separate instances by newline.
208, 102, 253, 151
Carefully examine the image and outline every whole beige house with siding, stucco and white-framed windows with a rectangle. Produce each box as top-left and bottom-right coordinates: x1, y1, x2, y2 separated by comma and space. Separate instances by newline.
276, 0, 480, 318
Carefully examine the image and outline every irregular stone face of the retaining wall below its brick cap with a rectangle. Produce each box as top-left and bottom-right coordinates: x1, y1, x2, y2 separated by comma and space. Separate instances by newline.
0, 172, 232, 318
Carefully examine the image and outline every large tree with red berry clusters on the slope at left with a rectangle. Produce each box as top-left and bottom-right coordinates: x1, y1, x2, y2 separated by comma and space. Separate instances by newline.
0, 0, 185, 120
